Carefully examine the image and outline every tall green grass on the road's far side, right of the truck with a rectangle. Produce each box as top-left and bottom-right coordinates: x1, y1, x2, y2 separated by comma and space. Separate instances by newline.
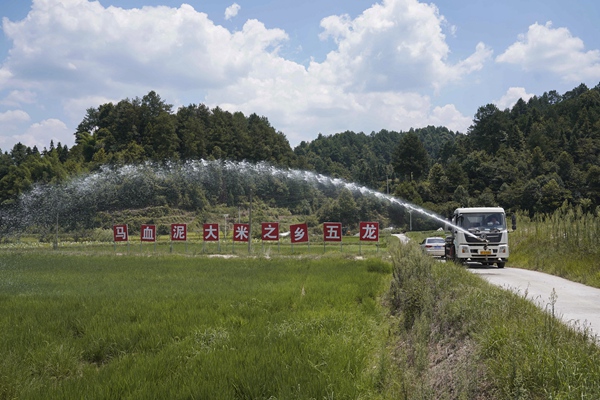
510, 206, 600, 287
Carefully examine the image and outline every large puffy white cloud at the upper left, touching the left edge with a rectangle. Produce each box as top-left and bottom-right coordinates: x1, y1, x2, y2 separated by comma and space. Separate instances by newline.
3, 0, 287, 92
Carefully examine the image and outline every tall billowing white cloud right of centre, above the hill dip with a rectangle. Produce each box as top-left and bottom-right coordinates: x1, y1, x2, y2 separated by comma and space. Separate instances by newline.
207, 0, 491, 144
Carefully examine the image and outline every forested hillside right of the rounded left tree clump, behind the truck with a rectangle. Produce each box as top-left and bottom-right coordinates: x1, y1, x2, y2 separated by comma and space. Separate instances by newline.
294, 84, 600, 219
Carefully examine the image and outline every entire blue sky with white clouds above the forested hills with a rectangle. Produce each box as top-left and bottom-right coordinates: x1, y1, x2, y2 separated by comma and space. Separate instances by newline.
0, 0, 600, 151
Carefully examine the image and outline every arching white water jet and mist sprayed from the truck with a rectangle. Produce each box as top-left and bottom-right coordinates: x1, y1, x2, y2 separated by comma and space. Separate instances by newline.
0, 160, 471, 241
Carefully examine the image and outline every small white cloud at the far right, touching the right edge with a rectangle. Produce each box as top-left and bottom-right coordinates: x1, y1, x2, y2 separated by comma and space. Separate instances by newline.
496, 22, 600, 82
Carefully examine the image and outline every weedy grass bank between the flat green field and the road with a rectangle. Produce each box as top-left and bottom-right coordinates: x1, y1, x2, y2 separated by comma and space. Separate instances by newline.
390, 239, 600, 399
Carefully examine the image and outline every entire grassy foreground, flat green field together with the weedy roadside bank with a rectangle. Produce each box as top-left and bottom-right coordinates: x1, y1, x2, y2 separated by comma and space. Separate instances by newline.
5, 234, 600, 400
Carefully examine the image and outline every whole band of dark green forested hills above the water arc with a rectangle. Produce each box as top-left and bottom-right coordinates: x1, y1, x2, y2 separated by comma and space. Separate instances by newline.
0, 84, 600, 217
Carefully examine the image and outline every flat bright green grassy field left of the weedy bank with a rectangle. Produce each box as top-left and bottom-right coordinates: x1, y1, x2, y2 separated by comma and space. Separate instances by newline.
0, 252, 393, 399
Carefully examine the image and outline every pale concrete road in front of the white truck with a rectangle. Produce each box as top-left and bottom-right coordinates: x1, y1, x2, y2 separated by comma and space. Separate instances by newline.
469, 265, 600, 338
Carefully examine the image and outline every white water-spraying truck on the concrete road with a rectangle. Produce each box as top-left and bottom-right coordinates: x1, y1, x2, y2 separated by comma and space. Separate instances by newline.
445, 207, 517, 268
